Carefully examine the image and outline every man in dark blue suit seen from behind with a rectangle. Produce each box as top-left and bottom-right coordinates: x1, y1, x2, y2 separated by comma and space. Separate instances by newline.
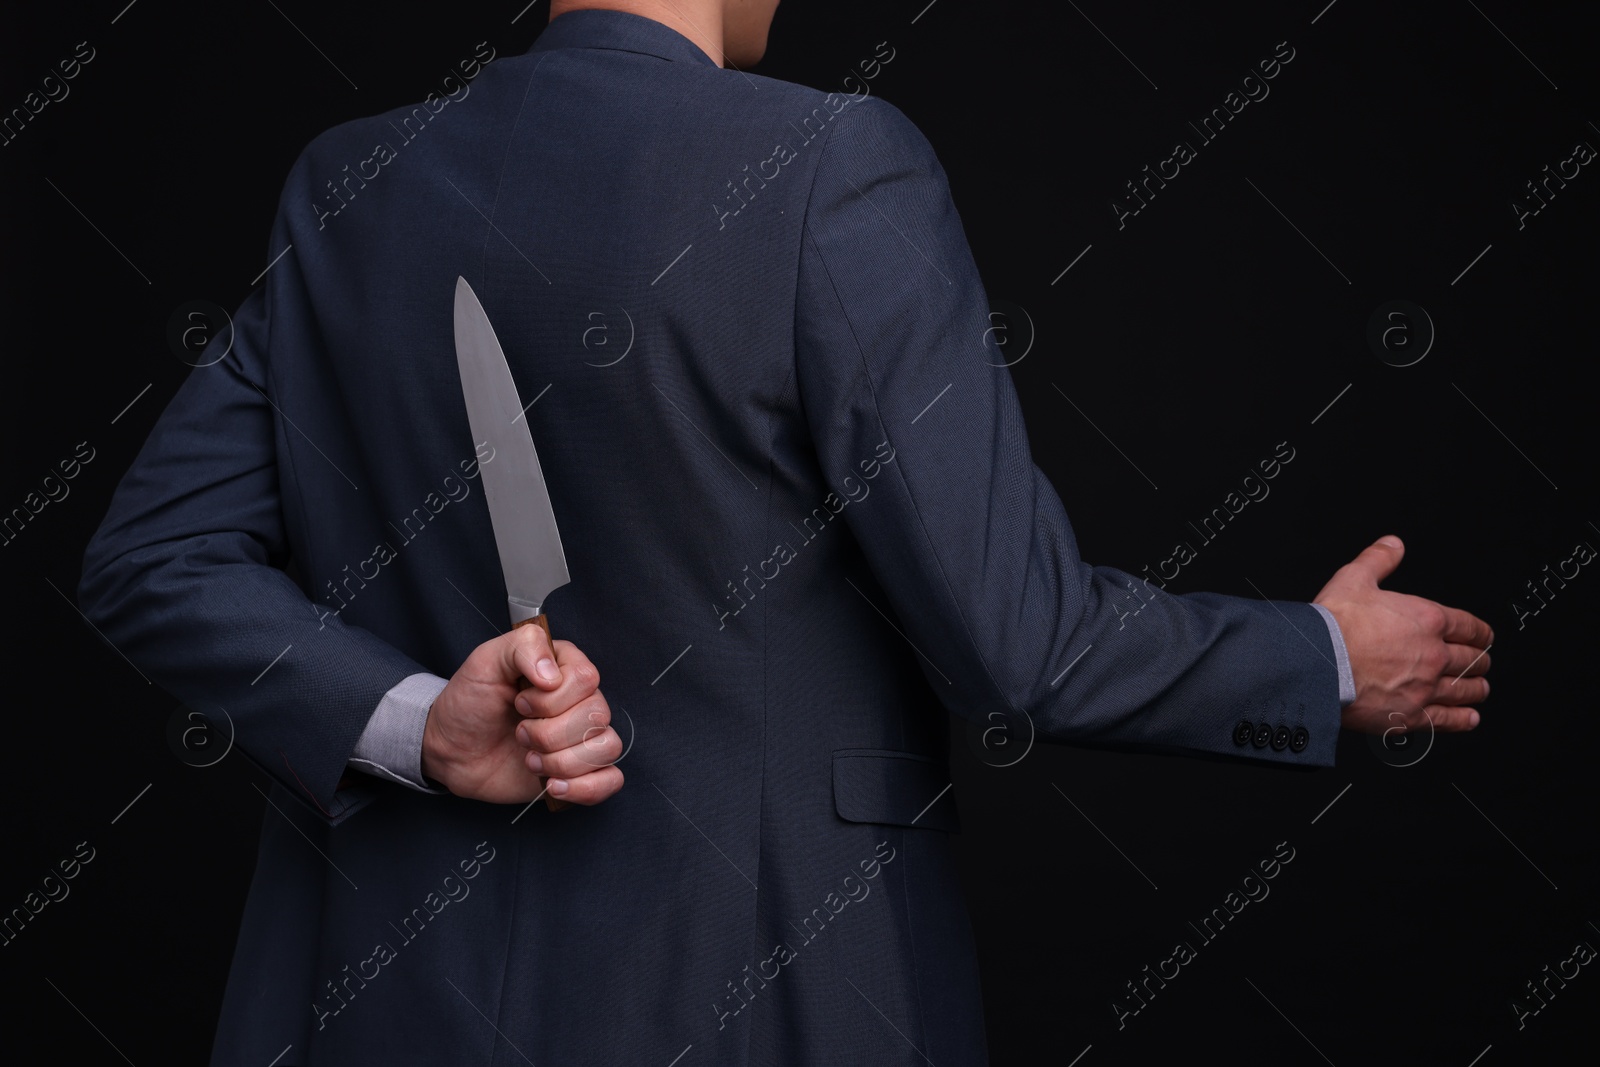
80, 0, 1490, 1065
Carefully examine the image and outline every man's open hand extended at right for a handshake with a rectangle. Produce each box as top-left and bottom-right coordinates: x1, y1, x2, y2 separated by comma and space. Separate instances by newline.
1312, 534, 1494, 734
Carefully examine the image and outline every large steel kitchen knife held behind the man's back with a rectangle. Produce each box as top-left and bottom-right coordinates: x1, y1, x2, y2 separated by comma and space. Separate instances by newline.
456, 277, 571, 811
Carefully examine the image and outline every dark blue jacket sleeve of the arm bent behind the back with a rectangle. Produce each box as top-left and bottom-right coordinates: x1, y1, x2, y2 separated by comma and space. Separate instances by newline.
78, 231, 441, 821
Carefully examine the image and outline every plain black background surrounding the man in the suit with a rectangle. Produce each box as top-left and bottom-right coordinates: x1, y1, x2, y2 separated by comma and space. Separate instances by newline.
0, 0, 1600, 1067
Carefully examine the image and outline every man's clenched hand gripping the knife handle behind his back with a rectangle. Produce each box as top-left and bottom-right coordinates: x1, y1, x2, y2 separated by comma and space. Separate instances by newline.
422, 625, 622, 805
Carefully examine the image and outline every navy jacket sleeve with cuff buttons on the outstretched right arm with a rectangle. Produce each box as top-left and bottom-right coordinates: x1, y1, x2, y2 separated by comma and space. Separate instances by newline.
795, 98, 1339, 765
